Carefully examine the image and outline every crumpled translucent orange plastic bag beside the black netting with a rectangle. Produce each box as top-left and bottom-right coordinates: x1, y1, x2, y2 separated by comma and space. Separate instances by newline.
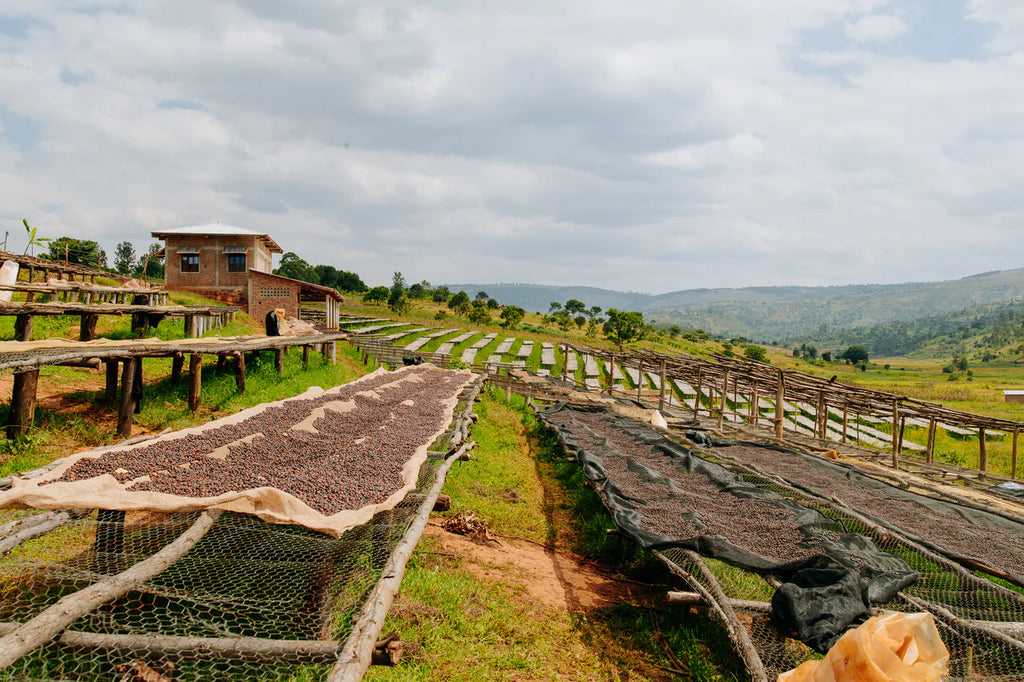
778, 613, 949, 682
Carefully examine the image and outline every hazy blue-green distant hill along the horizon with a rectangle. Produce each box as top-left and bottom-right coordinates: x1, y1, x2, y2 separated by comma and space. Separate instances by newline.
447, 268, 1024, 341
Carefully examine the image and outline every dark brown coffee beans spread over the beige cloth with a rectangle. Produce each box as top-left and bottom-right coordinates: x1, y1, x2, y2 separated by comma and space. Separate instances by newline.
47, 365, 472, 515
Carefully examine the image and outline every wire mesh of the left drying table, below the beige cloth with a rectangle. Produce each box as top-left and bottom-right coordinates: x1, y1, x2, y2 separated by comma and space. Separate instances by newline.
0, 460, 439, 680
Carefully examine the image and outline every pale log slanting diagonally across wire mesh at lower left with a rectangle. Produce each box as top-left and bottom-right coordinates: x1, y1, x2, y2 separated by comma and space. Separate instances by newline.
0, 510, 221, 670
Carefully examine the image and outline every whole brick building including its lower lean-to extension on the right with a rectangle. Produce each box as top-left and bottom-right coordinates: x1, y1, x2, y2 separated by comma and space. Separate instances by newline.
152, 222, 344, 329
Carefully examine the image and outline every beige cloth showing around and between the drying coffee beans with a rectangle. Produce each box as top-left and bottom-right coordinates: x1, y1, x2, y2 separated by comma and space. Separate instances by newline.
0, 365, 473, 537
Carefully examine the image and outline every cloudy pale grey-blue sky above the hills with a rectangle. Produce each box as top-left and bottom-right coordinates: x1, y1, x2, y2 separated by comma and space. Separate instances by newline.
0, 0, 1024, 293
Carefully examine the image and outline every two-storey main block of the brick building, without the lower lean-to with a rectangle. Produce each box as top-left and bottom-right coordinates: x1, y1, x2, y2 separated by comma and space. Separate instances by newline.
152, 222, 284, 304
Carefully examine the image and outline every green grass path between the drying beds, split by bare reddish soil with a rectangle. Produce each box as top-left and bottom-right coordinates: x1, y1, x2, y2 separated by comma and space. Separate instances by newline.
367, 390, 744, 681
